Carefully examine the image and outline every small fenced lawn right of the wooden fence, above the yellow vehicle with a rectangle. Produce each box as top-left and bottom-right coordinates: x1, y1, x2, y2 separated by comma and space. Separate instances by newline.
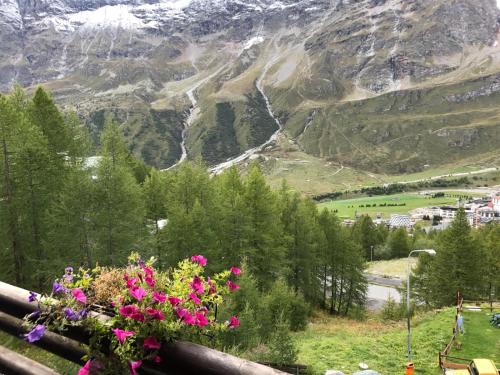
450, 309, 500, 366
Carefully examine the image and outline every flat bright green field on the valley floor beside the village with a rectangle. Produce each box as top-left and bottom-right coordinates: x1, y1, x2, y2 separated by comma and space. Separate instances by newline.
318, 193, 457, 219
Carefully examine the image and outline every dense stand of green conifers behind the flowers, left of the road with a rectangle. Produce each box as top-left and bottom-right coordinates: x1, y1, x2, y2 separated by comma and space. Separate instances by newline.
0, 88, 366, 314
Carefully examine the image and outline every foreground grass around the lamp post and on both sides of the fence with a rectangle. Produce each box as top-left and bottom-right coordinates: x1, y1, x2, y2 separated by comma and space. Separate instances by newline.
295, 308, 500, 375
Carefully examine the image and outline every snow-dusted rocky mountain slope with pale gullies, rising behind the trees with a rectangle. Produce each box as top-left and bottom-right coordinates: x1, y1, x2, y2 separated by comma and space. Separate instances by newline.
0, 0, 500, 173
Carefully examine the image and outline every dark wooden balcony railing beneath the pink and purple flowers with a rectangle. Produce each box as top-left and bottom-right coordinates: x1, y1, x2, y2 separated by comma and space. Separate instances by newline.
0, 282, 286, 375
